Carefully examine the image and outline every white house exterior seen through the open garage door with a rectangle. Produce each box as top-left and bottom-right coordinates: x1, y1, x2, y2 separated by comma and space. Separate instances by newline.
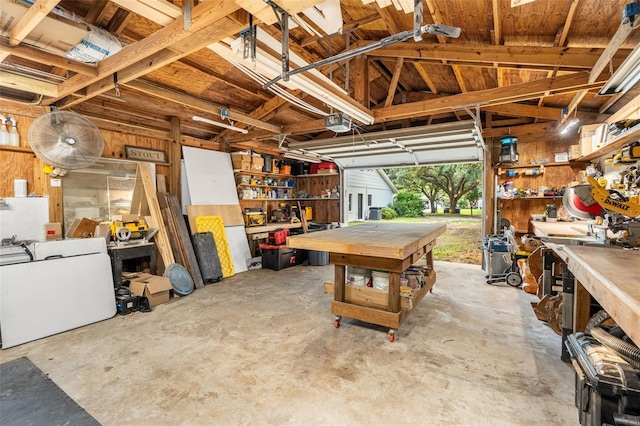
342, 169, 398, 222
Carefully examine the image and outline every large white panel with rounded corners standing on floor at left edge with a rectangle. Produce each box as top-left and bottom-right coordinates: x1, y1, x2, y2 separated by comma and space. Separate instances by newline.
0, 253, 116, 349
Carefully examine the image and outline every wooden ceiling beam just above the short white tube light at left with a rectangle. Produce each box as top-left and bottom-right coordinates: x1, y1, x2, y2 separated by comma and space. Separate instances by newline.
124, 80, 282, 133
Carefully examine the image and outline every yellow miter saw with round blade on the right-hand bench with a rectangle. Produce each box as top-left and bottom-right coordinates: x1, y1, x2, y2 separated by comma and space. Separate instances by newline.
562, 176, 640, 247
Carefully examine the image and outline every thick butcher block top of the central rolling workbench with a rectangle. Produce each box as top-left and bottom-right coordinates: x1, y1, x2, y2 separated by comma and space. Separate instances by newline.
287, 223, 447, 260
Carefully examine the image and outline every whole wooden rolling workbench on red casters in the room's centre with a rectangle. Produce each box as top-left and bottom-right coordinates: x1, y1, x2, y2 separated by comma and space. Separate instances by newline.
287, 223, 446, 341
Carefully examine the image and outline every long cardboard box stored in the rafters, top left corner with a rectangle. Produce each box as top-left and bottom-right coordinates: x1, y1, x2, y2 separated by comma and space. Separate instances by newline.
0, 0, 89, 55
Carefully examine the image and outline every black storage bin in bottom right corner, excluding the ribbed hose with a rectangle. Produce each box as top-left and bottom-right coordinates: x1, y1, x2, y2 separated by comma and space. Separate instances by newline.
565, 333, 640, 426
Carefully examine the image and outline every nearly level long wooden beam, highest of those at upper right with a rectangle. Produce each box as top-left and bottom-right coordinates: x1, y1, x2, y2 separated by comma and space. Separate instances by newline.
362, 42, 630, 70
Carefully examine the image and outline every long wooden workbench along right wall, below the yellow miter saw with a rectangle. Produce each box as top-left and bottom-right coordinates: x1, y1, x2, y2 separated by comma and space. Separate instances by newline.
563, 246, 640, 346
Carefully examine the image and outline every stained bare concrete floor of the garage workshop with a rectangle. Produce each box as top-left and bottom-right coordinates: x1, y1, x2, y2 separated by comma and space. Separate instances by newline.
0, 262, 578, 425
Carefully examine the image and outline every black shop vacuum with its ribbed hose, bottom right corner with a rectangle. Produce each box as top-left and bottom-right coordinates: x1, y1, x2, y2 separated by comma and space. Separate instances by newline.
565, 326, 640, 426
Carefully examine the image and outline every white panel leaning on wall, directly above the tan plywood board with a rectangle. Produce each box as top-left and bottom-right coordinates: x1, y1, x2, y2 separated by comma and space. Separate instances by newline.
182, 146, 238, 205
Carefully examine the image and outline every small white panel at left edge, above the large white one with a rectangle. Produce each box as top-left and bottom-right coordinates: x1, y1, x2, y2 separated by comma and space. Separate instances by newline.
0, 197, 49, 241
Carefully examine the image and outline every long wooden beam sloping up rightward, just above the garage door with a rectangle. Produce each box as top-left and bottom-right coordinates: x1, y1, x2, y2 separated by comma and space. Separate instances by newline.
373, 73, 606, 122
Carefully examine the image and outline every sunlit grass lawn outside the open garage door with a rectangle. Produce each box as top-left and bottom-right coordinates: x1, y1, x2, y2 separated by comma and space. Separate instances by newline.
349, 213, 482, 265
